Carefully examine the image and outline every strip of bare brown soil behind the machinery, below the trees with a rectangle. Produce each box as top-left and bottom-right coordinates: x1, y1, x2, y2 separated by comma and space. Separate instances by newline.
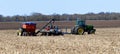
0, 20, 120, 29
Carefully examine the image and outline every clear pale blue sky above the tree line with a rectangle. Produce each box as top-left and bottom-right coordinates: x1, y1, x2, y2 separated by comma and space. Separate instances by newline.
0, 0, 120, 16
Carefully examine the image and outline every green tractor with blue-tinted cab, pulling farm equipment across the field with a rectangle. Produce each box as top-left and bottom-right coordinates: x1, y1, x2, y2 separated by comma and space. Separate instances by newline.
71, 20, 96, 35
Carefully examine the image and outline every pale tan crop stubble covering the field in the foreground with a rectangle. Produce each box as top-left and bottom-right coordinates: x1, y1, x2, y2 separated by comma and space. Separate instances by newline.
0, 28, 120, 54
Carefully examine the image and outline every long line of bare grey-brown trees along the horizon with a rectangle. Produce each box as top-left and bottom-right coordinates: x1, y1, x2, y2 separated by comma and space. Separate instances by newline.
0, 12, 120, 22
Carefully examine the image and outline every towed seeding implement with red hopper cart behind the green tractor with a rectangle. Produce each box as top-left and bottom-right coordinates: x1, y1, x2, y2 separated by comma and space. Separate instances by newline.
17, 19, 63, 36
